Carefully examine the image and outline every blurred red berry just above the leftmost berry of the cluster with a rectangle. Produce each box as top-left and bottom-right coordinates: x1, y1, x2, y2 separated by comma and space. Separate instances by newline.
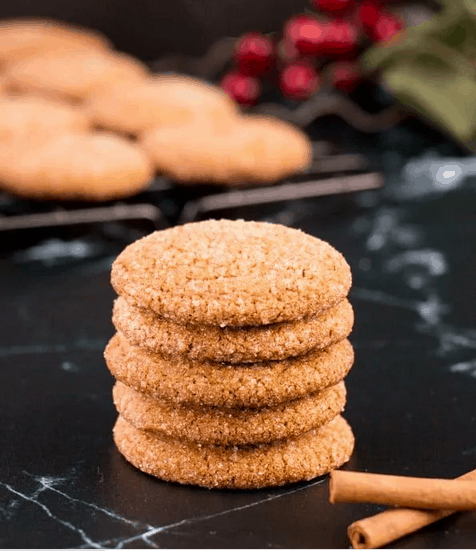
233, 33, 274, 76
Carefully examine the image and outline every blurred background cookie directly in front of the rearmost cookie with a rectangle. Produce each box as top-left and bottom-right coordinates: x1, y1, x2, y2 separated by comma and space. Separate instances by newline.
6, 49, 147, 100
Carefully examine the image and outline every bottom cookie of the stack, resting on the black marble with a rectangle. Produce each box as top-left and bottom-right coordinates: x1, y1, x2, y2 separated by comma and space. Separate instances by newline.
114, 416, 354, 489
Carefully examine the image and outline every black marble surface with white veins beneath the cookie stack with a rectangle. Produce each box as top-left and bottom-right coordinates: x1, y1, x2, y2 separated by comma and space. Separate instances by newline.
0, 119, 476, 548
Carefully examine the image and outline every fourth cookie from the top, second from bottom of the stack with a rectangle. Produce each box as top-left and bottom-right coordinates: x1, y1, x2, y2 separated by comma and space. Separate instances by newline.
113, 382, 346, 446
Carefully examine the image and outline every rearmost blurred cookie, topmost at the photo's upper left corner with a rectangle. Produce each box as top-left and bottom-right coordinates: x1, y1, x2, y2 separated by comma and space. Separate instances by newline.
0, 18, 112, 63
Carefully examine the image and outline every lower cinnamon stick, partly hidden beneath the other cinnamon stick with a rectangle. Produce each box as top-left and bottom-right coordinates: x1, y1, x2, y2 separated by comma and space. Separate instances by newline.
330, 469, 476, 549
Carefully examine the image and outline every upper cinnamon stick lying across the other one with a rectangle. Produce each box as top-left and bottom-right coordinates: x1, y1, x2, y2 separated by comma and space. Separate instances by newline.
329, 471, 476, 511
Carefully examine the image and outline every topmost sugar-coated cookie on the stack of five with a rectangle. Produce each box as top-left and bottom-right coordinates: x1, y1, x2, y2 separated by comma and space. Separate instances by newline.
111, 220, 351, 327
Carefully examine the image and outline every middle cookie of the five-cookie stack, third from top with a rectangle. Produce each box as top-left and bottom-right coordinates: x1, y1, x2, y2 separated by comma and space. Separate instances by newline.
105, 333, 354, 408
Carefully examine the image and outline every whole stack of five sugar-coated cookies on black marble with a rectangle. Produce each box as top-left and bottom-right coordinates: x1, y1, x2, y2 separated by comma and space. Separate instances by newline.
105, 220, 354, 488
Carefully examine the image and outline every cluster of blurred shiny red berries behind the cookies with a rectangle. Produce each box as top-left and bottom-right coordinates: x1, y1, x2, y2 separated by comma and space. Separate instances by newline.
220, 0, 404, 106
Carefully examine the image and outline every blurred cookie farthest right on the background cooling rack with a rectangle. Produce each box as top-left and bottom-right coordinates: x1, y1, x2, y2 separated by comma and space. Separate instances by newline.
142, 116, 312, 184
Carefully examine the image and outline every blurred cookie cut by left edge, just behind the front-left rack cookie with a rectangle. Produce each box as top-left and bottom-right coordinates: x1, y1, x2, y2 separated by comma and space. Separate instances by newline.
0, 96, 91, 144
